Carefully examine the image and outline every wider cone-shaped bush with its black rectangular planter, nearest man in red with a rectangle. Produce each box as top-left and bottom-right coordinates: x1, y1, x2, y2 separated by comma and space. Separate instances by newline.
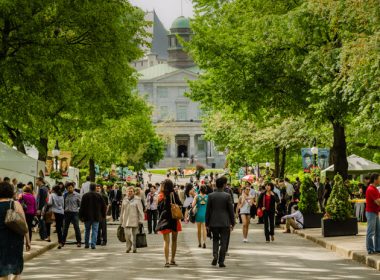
322, 174, 358, 237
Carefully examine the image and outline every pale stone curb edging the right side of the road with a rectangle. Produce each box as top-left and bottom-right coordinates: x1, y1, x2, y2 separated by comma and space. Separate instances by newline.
281, 225, 380, 271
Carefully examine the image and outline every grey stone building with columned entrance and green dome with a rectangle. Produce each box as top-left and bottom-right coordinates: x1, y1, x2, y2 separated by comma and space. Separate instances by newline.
138, 14, 225, 168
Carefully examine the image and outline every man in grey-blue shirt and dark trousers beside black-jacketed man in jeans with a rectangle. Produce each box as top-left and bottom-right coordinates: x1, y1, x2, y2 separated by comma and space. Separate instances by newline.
62, 182, 82, 248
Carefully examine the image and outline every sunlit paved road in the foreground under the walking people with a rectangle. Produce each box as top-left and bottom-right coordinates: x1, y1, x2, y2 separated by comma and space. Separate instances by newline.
23, 221, 380, 280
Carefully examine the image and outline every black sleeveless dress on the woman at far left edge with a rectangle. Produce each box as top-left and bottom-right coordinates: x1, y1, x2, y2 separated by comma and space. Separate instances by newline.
0, 201, 24, 277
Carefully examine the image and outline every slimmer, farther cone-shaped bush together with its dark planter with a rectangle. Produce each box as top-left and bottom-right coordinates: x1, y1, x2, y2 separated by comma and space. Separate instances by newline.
298, 175, 323, 228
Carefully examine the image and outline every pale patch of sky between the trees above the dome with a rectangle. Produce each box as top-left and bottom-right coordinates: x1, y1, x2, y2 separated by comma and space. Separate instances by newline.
129, 0, 193, 29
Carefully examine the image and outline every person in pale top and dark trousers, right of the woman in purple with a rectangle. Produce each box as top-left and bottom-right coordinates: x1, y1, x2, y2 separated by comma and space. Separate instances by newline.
48, 185, 65, 249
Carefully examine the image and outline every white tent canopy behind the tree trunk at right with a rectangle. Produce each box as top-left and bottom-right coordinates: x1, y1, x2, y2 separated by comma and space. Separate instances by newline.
322, 155, 380, 175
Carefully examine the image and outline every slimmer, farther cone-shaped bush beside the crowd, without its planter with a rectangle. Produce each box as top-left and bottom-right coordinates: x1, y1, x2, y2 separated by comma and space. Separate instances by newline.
298, 175, 318, 214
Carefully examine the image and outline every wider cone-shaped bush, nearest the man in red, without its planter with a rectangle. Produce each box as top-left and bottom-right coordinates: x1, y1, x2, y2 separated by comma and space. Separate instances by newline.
326, 174, 352, 221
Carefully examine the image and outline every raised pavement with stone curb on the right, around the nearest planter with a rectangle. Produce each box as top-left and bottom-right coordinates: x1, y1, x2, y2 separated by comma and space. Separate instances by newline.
284, 225, 380, 271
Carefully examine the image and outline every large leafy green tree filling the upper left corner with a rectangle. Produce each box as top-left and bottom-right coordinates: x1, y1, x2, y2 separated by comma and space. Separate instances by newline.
0, 0, 146, 159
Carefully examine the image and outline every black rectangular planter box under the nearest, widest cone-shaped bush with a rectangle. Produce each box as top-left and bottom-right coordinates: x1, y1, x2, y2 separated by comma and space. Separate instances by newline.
322, 218, 358, 237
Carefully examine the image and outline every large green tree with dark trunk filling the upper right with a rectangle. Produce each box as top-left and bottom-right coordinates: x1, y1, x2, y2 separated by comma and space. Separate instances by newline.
187, 0, 380, 178
